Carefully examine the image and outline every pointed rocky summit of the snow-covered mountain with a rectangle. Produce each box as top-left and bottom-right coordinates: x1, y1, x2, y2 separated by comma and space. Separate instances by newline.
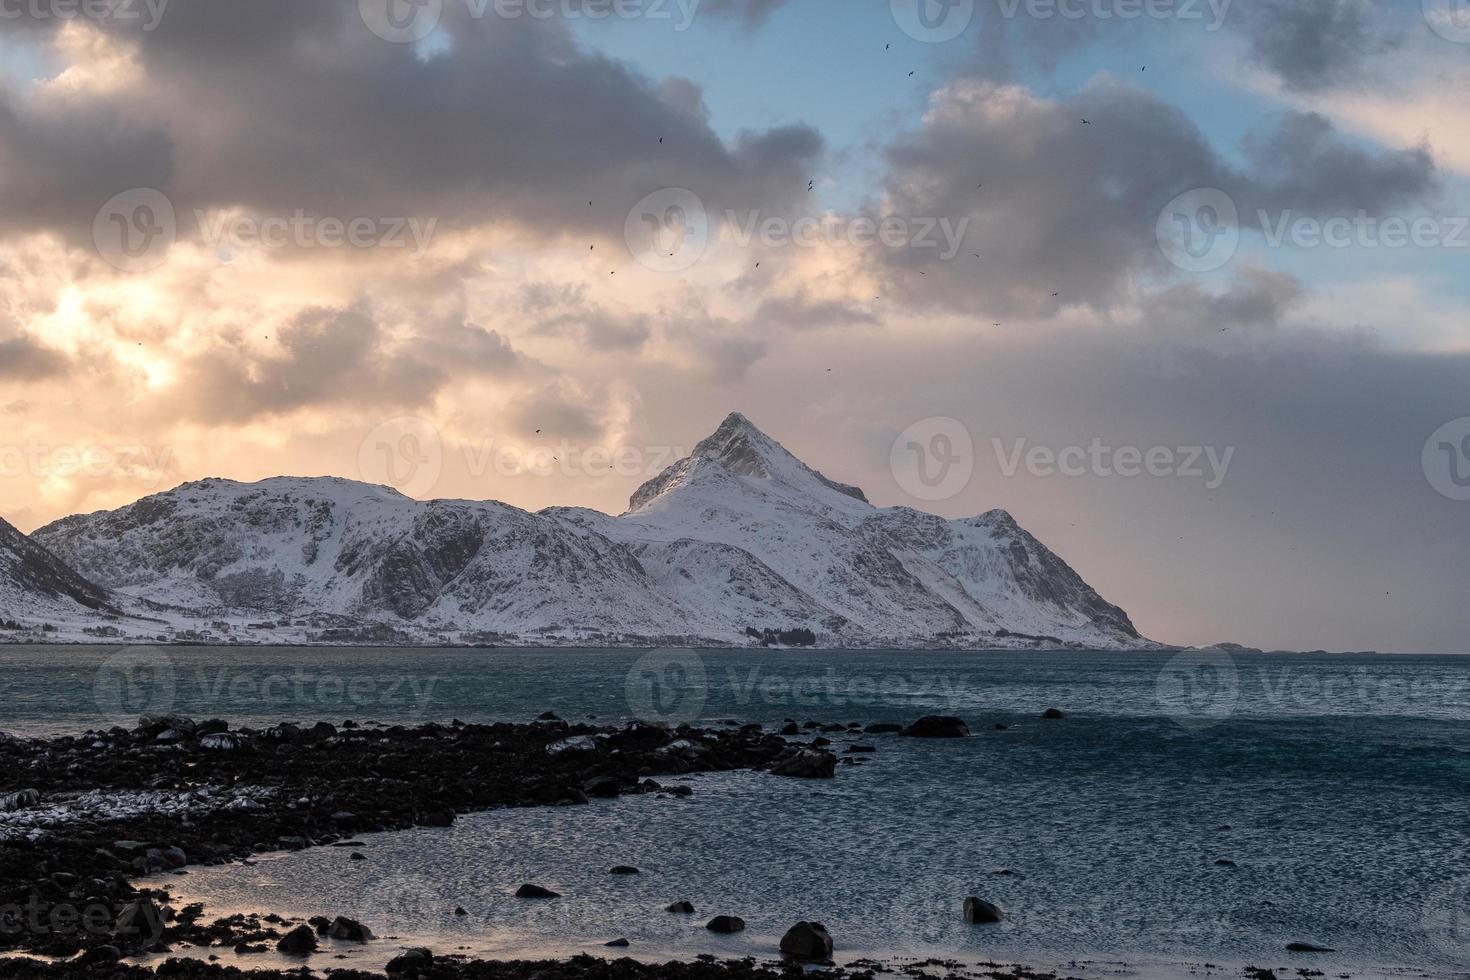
628, 411, 867, 513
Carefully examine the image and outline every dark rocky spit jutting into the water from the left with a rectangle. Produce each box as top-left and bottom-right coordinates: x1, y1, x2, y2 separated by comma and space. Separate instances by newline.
0, 714, 893, 977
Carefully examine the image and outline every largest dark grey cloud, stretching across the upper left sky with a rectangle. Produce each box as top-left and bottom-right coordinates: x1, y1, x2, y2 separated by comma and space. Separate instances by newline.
0, 0, 822, 245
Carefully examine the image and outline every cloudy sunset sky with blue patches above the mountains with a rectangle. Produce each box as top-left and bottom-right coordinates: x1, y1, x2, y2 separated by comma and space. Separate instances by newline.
0, 0, 1470, 652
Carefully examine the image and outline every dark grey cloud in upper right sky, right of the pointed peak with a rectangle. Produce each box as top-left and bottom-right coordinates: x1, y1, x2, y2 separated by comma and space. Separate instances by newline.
875, 79, 1438, 314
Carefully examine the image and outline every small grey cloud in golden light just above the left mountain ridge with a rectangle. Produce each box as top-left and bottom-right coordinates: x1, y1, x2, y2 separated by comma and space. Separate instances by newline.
176, 304, 537, 423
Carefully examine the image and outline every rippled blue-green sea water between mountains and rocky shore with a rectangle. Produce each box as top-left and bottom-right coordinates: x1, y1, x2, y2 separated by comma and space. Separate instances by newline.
0, 648, 1470, 976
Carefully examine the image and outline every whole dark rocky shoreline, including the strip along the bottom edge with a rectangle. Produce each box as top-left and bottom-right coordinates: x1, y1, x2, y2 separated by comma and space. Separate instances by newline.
0, 716, 1449, 980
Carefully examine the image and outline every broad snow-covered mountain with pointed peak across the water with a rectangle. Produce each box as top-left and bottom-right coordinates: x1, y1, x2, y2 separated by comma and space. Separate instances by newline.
17, 414, 1152, 649
